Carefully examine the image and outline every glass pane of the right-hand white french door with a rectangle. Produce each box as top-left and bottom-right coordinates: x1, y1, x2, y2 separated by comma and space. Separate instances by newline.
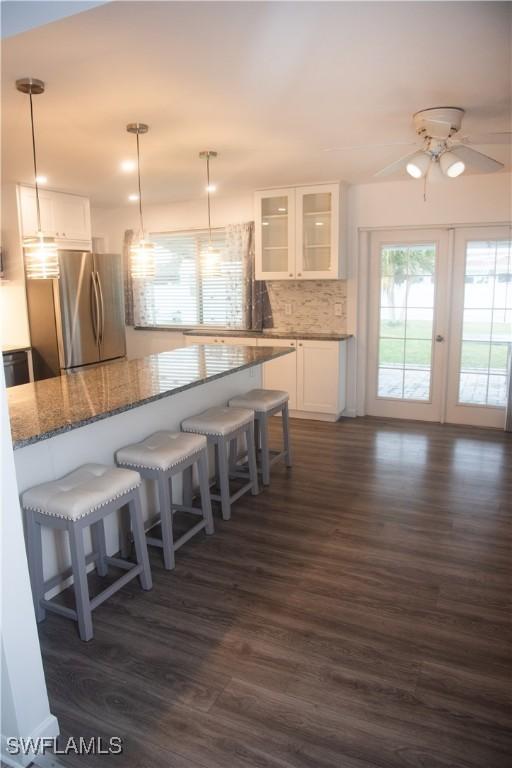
459, 240, 512, 407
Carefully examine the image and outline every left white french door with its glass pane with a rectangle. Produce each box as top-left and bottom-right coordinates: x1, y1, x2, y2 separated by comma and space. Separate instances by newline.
366, 230, 448, 421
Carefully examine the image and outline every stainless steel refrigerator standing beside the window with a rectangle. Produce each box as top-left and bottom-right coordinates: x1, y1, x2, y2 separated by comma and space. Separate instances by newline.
27, 250, 126, 380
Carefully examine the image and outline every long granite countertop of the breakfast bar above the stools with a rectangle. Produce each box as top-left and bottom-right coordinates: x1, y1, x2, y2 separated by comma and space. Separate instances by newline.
7, 344, 294, 449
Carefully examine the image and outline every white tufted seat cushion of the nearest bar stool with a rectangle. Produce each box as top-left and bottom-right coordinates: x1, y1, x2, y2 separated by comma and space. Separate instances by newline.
21, 464, 141, 520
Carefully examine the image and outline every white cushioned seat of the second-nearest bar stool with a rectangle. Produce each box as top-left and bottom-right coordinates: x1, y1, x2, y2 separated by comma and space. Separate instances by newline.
116, 431, 206, 472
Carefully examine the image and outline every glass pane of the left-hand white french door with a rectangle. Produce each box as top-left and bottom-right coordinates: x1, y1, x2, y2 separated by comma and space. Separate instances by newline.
377, 243, 436, 401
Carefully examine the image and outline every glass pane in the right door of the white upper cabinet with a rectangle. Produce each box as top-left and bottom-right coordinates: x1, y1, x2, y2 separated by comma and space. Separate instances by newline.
302, 192, 332, 272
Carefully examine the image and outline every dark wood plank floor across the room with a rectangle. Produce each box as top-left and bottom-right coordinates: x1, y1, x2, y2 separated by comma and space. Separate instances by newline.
40, 418, 512, 768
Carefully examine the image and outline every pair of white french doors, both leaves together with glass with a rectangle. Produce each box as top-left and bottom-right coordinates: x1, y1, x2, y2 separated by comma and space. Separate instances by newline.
366, 227, 512, 427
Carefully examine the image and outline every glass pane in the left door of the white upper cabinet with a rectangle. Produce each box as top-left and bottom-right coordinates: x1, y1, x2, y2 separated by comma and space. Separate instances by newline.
261, 195, 288, 272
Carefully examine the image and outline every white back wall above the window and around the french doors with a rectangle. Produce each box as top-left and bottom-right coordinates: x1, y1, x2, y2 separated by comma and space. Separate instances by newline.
92, 173, 512, 415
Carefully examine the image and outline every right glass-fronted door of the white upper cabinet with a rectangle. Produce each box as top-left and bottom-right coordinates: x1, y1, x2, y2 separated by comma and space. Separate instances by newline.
296, 184, 340, 280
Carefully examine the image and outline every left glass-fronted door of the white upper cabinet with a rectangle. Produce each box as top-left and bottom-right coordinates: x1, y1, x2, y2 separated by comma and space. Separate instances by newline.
255, 189, 295, 280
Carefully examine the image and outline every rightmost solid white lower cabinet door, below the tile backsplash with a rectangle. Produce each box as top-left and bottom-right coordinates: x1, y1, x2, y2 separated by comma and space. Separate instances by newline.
297, 341, 340, 414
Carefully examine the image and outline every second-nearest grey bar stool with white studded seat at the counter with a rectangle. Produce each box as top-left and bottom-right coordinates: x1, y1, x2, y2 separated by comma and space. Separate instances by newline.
116, 432, 213, 570
